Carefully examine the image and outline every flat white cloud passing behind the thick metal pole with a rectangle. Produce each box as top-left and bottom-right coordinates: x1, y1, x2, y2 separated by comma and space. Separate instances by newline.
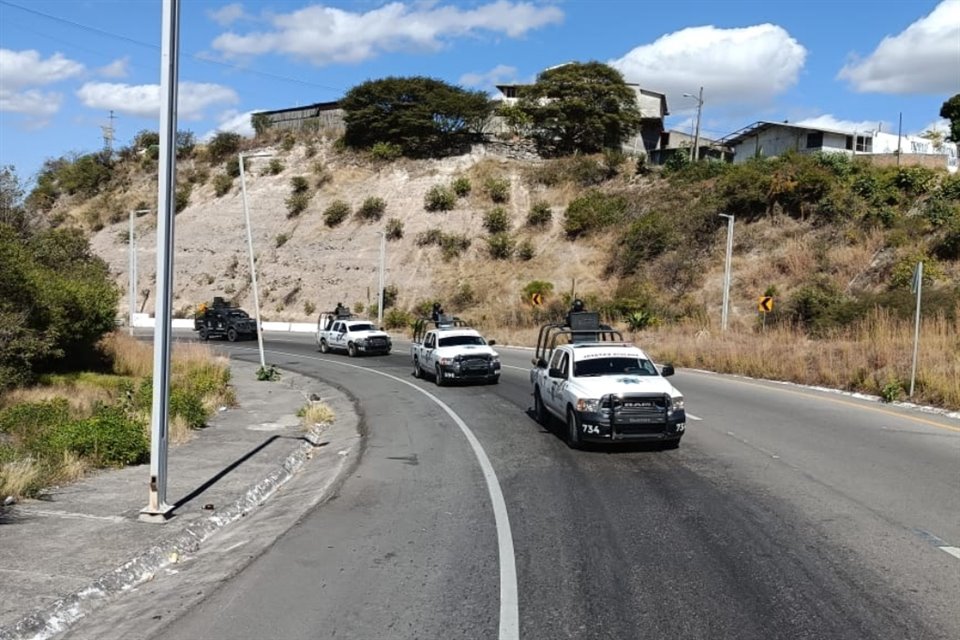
77, 82, 240, 120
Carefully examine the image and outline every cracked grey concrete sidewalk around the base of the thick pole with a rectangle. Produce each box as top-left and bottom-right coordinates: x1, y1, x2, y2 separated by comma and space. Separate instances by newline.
0, 360, 360, 640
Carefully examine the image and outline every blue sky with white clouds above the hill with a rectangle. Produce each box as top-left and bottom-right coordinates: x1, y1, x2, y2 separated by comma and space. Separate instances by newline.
0, 0, 960, 183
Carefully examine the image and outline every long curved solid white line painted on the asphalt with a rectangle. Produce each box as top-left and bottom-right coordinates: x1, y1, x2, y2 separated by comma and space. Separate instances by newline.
255, 349, 520, 640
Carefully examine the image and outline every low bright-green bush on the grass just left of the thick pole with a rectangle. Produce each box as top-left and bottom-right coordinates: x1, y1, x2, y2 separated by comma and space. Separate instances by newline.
52, 405, 150, 467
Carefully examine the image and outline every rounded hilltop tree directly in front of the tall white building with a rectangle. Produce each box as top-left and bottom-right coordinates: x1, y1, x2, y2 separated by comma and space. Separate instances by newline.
518, 62, 640, 155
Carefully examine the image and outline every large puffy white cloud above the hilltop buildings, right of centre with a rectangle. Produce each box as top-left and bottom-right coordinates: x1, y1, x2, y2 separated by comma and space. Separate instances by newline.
609, 24, 807, 111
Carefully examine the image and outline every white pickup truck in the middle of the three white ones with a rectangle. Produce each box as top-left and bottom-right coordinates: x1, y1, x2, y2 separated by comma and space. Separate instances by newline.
410, 318, 500, 386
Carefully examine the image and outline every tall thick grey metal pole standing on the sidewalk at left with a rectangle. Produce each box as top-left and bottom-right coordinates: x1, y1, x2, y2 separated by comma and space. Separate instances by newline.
140, 0, 180, 522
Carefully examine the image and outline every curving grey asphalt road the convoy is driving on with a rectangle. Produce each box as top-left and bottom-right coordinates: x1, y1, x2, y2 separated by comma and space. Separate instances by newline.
154, 336, 960, 640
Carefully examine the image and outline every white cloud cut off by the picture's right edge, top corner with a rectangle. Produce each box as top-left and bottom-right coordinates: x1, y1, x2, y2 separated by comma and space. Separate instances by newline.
837, 0, 960, 94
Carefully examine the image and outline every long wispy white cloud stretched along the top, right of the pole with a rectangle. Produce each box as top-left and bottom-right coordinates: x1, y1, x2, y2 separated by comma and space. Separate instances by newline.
213, 0, 563, 65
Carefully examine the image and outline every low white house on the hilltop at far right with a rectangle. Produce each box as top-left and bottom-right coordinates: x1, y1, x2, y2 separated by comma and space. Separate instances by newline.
718, 121, 958, 173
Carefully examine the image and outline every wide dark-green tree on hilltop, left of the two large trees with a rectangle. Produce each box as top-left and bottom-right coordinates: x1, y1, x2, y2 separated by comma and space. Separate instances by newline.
340, 76, 491, 157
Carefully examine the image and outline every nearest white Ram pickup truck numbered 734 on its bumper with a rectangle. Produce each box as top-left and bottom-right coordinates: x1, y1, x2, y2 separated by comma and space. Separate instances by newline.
530, 314, 686, 448
